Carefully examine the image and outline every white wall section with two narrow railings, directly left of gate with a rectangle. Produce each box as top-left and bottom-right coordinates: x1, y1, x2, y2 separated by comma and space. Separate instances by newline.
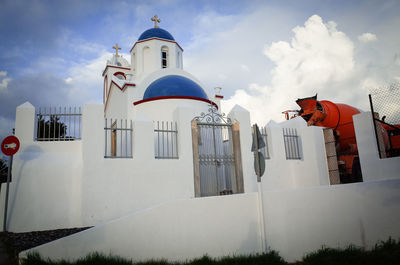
82, 104, 200, 225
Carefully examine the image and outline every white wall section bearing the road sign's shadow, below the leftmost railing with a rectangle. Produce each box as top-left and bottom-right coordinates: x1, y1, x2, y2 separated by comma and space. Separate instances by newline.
0, 102, 82, 232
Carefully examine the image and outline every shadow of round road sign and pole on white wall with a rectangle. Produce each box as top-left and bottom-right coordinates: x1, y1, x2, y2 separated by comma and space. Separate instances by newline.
7, 145, 43, 230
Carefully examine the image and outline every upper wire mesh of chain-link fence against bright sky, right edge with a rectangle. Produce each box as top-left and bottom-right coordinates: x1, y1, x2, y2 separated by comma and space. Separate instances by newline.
370, 83, 400, 124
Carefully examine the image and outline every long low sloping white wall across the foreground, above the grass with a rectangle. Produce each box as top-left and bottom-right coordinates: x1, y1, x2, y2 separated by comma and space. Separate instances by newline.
21, 179, 400, 262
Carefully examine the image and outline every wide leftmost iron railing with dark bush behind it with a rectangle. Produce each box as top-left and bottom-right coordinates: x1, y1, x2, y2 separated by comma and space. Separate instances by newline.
35, 107, 82, 141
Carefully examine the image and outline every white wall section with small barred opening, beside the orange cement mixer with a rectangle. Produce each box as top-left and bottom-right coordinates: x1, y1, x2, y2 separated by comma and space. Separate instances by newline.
262, 117, 329, 190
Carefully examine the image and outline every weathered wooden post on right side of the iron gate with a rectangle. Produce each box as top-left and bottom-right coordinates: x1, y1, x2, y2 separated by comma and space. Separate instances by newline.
232, 122, 244, 193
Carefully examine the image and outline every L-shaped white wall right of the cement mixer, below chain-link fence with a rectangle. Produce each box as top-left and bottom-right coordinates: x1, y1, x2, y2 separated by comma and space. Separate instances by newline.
353, 112, 400, 181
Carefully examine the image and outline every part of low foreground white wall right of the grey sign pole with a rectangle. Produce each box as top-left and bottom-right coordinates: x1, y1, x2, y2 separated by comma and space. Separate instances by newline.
263, 179, 400, 262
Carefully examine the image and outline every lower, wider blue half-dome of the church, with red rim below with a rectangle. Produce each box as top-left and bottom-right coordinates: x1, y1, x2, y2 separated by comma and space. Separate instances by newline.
143, 75, 208, 101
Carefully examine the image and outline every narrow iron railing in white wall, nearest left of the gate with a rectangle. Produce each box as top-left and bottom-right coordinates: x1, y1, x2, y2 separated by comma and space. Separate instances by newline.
154, 121, 179, 159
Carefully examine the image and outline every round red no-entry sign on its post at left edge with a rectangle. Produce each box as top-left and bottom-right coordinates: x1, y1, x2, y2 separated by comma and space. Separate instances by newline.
1, 136, 20, 232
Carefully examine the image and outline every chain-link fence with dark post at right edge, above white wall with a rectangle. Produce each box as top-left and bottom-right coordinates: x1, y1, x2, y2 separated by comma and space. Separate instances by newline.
369, 82, 400, 158
